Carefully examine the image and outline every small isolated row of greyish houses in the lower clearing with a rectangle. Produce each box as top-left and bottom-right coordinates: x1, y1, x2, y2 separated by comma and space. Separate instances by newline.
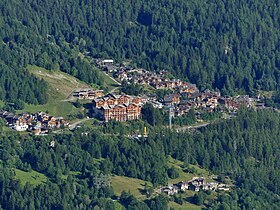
160, 177, 230, 195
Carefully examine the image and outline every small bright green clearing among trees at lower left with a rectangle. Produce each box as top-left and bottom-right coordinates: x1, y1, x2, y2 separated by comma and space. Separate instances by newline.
14, 169, 48, 185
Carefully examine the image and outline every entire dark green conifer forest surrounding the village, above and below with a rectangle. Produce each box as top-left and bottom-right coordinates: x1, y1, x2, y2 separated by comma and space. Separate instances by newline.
0, 0, 280, 210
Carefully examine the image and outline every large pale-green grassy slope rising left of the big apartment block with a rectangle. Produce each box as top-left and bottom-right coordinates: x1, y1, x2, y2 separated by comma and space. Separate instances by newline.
18, 65, 118, 117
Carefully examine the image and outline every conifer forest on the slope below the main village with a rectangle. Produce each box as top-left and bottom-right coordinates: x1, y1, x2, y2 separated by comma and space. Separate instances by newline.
0, 110, 280, 209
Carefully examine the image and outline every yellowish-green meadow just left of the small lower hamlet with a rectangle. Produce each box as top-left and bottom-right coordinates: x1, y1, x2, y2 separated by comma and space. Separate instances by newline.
112, 176, 152, 199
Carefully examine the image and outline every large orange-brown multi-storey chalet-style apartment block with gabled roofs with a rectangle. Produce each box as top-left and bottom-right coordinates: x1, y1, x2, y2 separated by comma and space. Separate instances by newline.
92, 94, 143, 122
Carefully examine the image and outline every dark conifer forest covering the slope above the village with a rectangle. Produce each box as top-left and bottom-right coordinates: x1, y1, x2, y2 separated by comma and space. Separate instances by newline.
0, 0, 280, 103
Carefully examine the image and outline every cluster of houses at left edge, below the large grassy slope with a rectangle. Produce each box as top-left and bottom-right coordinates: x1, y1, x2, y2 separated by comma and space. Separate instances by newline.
0, 110, 69, 135
